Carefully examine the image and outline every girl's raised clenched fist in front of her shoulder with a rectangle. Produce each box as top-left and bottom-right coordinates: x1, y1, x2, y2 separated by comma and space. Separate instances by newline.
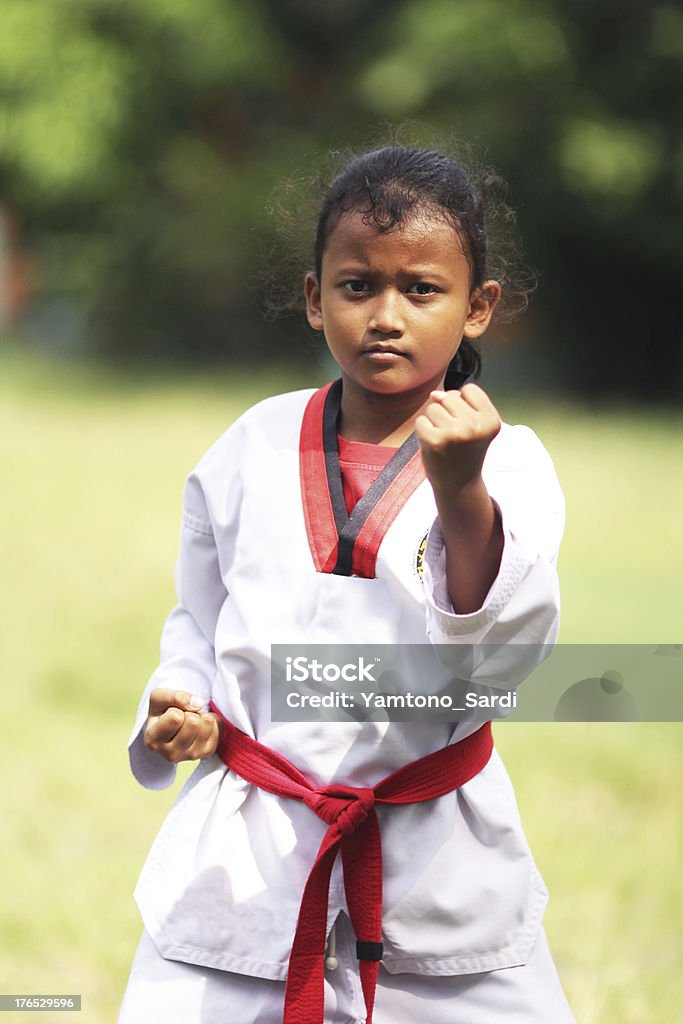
415, 384, 501, 494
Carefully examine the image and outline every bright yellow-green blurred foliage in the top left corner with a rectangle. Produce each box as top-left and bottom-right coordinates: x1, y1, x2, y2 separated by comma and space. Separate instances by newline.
0, 0, 276, 202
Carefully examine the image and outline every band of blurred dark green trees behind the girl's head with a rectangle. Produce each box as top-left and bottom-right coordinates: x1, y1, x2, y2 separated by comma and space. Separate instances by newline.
0, 0, 683, 397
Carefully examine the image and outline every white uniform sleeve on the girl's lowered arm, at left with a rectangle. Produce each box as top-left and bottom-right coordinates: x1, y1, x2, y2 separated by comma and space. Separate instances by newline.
128, 476, 227, 790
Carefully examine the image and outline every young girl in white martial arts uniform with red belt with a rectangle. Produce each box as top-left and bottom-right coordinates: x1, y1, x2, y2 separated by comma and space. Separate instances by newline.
120, 146, 572, 1024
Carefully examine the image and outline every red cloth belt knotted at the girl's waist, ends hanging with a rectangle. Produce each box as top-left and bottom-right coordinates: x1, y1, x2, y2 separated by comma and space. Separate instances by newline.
211, 702, 494, 1024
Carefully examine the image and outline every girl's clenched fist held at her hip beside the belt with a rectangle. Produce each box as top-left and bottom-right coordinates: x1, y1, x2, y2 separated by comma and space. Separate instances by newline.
144, 688, 220, 764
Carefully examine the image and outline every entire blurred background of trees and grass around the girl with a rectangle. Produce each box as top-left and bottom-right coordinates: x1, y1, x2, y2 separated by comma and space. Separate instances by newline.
0, 0, 683, 1024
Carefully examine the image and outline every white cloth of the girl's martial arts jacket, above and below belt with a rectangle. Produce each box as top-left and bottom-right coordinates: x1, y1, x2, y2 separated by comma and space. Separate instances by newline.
130, 391, 564, 979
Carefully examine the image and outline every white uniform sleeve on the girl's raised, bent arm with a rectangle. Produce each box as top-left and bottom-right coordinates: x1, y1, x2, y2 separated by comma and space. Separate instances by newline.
424, 426, 564, 688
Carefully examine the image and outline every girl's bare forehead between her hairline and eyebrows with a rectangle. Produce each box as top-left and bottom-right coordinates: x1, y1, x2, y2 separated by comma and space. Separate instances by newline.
324, 210, 465, 264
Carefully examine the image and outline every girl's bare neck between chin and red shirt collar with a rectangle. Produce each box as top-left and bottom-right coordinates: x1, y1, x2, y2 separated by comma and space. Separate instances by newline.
338, 377, 442, 447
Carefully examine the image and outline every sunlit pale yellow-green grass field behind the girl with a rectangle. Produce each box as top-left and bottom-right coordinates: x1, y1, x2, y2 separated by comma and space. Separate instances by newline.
0, 349, 683, 1024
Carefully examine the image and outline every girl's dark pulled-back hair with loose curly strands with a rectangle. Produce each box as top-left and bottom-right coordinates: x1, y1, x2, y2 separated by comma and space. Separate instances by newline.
270, 134, 533, 379
